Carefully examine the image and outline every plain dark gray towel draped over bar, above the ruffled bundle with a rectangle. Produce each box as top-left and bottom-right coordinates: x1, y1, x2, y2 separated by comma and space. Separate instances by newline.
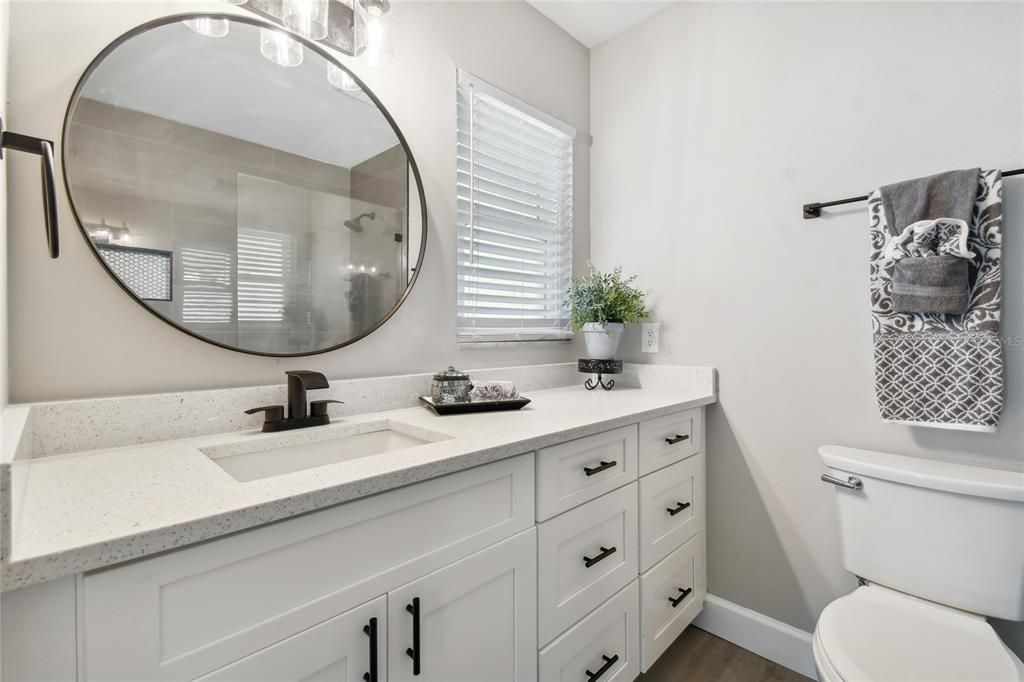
879, 168, 981, 228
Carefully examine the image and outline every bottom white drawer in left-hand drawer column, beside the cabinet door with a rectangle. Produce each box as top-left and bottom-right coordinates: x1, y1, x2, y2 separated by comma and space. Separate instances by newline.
540, 581, 640, 682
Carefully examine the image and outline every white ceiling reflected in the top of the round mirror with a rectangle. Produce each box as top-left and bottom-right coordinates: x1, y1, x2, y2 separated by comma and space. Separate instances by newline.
82, 22, 398, 168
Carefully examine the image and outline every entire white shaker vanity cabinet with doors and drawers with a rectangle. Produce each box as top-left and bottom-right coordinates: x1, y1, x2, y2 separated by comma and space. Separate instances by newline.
3, 408, 707, 682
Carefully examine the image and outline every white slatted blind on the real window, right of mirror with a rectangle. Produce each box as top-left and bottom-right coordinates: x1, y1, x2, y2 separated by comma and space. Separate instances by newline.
457, 74, 575, 343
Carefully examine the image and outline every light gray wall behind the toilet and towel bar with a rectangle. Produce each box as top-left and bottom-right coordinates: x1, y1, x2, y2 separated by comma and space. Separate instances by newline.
591, 2, 1024, 650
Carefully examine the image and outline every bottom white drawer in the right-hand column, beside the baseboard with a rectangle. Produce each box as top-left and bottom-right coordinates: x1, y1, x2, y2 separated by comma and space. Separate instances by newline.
640, 532, 708, 673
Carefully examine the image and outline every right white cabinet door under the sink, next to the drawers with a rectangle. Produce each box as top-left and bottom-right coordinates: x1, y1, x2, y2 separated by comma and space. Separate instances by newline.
388, 529, 537, 682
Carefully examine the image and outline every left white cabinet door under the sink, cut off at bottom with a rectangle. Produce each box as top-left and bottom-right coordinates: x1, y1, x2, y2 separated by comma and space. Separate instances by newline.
200, 597, 387, 682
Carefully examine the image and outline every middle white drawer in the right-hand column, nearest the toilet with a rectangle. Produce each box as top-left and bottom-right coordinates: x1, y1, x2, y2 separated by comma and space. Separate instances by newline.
640, 454, 705, 570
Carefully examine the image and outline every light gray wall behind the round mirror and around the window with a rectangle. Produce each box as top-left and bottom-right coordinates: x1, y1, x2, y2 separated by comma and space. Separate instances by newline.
7, 1, 590, 401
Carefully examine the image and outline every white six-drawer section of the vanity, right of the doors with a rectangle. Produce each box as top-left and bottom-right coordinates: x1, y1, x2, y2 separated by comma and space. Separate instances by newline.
537, 408, 707, 682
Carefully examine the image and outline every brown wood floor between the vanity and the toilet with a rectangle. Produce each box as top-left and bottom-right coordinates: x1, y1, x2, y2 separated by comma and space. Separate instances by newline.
639, 627, 808, 682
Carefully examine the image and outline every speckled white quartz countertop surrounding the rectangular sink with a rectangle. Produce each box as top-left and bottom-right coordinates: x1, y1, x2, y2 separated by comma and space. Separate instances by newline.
2, 371, 715, 590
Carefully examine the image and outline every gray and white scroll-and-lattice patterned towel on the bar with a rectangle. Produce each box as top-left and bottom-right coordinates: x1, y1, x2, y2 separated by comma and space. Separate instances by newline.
868, 170, 1002, 431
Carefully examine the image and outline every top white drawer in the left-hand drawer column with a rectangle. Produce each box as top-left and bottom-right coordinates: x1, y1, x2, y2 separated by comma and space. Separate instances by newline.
537, 424, 637, 521
